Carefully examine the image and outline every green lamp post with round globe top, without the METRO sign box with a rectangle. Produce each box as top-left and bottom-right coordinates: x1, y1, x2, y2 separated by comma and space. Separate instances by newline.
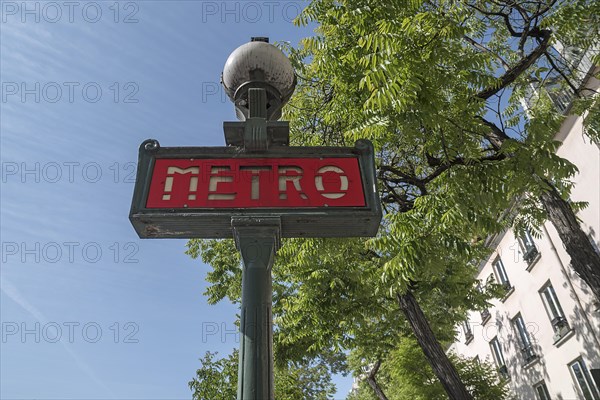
222, 38, 296, 400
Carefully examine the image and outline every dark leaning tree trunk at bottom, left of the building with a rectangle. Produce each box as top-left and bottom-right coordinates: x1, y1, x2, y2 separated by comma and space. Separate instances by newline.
397, 291, 473, 400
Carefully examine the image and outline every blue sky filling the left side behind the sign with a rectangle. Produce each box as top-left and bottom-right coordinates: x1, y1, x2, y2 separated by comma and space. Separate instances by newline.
0, 1, 351, 399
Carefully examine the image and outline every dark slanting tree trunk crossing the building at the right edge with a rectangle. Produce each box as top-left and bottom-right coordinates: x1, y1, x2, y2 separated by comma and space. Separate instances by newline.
540, 183, 600, 301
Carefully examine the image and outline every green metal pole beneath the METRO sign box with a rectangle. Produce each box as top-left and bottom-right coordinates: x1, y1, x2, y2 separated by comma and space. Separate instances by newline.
231, 216, 281, 400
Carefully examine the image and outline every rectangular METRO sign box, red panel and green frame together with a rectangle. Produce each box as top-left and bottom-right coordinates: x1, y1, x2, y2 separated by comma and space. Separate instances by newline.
130, 140, 381, 238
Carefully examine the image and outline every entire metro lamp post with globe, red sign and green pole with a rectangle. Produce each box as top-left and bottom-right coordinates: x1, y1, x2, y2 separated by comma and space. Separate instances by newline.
129, 34, 382, 400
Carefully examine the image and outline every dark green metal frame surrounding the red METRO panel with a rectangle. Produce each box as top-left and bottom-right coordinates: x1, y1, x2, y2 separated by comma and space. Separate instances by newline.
129, 139, 382, 239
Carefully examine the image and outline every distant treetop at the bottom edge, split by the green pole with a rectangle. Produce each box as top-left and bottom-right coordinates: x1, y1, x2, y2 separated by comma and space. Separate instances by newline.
189, 350, 335, 400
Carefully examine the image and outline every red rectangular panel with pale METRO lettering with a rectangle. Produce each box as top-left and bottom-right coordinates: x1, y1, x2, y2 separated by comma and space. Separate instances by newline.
146, 157, 365, 208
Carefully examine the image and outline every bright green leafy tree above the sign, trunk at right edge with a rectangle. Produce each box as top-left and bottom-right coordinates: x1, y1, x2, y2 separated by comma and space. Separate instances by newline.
296, 0, 600, 299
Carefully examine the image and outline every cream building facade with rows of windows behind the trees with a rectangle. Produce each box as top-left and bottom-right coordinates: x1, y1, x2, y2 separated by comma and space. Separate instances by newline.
450, 69, 600, 400
